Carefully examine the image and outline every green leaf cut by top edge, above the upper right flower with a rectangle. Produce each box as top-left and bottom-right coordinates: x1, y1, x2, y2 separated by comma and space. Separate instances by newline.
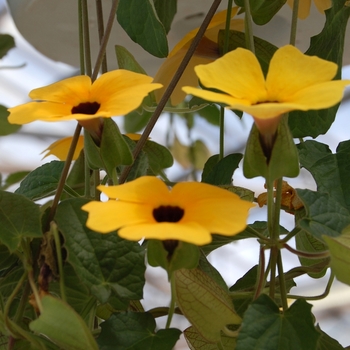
235, 0, 287, 25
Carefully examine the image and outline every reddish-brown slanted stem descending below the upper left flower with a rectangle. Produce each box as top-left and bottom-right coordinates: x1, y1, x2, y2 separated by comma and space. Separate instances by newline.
47, 123, 82, 226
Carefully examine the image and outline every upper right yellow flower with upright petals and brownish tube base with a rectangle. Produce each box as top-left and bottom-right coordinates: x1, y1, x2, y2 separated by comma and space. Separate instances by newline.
183, 45, 350, 134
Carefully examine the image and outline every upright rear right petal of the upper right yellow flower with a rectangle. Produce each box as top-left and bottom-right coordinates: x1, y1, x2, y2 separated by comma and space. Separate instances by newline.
261, 45, 338, 102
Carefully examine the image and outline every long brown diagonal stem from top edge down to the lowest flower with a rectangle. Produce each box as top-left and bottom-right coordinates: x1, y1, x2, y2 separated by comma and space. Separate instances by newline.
119, 0, 221, 184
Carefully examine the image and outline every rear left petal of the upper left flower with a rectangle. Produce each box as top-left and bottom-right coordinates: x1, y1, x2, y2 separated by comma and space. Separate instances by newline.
29, 75, 91, 106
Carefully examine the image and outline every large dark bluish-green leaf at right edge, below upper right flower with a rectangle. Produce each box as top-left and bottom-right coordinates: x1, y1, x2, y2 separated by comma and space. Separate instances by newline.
298, 141, 350, 239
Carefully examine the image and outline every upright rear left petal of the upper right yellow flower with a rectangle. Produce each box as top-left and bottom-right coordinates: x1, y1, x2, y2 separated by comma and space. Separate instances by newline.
195, 48, 267, 104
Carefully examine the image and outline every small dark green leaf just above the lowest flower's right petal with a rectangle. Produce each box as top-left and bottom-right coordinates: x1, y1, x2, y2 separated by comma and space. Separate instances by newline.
202, 153, 243, 186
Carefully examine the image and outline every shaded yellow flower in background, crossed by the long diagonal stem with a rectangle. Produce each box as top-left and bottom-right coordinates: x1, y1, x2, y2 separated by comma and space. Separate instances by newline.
154, 7, 244, 106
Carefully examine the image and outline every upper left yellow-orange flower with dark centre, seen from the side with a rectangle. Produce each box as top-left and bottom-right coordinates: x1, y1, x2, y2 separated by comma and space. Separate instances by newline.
8, 69, 162, 124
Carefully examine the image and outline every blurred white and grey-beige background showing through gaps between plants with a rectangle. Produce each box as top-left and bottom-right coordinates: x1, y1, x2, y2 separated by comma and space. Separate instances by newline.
0, 0, 350, 349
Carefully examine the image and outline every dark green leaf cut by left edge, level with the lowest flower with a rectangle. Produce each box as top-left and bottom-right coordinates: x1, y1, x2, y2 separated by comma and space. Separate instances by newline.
0, 191, 42, 252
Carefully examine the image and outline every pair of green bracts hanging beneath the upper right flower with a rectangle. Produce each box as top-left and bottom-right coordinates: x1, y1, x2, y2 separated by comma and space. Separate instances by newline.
243, 118, 299, 181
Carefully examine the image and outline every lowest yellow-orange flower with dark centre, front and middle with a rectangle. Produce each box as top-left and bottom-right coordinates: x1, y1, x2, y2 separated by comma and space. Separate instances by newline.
82, 176, 254, 245
